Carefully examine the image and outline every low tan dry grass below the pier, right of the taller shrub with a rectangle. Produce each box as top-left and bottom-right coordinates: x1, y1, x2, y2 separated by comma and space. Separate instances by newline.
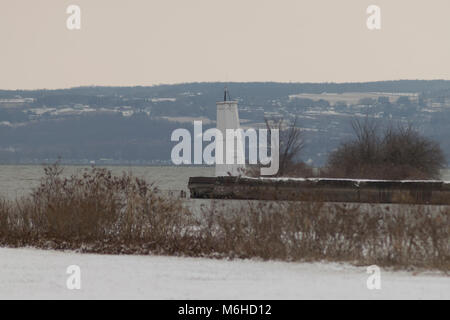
199, 202, 450, 271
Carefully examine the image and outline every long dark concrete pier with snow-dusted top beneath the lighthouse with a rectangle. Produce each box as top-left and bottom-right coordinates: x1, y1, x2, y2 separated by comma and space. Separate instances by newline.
188, 177, 450, 205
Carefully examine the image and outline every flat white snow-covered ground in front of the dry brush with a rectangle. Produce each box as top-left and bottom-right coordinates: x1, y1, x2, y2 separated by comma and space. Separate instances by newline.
0, 248, 450, 299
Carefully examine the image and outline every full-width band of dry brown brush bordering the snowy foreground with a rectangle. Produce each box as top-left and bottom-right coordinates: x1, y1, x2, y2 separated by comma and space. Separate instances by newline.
0, 166, 450, 271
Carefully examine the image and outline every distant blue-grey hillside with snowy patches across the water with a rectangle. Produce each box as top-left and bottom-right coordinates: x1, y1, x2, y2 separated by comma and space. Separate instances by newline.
0, 80, 450, 165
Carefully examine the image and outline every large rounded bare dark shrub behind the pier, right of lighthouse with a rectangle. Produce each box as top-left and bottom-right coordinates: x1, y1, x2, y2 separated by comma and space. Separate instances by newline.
324, 118, 446, 180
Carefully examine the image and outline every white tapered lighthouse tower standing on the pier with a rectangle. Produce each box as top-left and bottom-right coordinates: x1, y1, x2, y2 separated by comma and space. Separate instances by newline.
216, 88, 245, 177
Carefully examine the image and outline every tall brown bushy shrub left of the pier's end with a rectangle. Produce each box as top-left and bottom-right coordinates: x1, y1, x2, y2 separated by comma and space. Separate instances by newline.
0, 165, 200, 252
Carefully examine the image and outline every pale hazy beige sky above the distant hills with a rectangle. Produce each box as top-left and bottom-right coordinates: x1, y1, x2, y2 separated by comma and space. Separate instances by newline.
0, 0, 450, 89
